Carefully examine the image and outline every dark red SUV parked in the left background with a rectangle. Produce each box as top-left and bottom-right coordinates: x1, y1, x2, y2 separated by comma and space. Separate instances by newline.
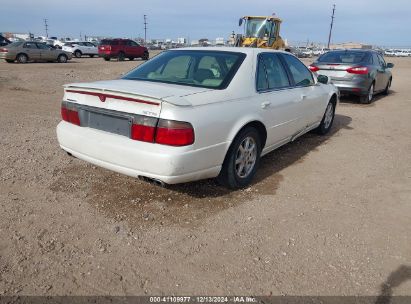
98, 39, 149, 61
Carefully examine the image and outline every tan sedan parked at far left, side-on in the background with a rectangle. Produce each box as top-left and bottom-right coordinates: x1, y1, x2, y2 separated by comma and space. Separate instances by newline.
0, 41, 72, 63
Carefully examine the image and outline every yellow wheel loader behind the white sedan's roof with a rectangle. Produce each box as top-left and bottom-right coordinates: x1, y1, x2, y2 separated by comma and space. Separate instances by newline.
235, 16, 286, 50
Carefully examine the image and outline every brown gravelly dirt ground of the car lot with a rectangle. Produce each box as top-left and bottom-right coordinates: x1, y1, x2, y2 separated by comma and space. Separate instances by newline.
0, 52, 411, 295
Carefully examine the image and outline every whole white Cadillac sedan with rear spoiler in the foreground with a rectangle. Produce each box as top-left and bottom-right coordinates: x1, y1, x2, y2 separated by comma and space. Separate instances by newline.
57, 47, 339, 188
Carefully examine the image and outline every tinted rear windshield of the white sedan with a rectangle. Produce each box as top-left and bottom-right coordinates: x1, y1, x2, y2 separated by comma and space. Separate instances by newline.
123, 50, 246, 89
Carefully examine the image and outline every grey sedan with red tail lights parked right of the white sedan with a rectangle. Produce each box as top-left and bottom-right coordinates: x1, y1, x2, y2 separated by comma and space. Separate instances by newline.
310, 49, 394, 103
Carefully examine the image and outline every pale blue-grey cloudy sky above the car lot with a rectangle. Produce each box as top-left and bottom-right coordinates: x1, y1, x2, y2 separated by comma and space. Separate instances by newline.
0, 0, 411, 46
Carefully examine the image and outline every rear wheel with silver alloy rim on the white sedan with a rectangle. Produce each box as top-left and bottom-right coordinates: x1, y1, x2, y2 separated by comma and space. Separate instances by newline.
217, 127, 261, 189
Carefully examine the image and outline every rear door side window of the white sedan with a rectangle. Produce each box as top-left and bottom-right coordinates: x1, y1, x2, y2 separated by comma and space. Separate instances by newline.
257, 53, 290, 91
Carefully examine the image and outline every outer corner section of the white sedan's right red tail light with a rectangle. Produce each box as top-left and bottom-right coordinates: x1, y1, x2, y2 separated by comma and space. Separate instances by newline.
155, 119, 194, 146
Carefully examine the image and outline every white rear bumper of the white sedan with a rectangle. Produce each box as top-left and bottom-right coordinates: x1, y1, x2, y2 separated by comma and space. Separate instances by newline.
57, 121, 228, 184
